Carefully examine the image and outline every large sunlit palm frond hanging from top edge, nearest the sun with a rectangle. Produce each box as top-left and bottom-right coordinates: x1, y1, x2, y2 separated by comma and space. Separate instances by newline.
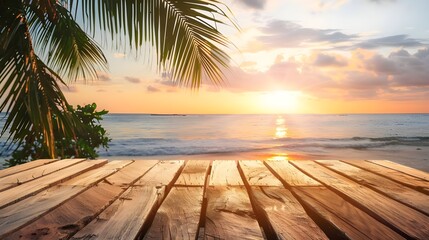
69, 0, 234, 88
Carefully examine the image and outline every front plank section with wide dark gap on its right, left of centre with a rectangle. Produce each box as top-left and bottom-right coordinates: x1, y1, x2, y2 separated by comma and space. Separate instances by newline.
144, 187, 204, 239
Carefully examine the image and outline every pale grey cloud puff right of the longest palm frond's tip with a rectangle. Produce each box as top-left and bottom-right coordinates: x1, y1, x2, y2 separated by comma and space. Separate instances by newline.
248, 20, 357, 51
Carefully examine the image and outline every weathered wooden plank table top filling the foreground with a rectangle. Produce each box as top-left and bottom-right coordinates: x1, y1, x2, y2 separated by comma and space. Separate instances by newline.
0, 159, 429, 239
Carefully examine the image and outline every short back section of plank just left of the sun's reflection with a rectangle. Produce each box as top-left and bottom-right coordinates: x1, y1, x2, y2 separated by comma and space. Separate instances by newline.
239, 160, 283, 186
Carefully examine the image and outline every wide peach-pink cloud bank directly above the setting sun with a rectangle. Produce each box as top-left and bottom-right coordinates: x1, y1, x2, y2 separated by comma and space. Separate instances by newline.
217, 48, 429, 100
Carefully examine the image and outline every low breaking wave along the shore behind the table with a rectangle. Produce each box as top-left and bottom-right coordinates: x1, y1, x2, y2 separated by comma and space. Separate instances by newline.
0, 137, 429, 156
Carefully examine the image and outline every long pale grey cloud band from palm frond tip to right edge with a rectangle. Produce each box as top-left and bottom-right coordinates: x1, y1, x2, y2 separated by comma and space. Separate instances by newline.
243, 19, 429, 53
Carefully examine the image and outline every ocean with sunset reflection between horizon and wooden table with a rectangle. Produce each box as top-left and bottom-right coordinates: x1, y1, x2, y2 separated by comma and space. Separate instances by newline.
0, 114, 429, 172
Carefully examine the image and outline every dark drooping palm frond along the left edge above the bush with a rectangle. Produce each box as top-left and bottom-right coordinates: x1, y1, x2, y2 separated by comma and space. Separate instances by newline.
0, 1, 80, 158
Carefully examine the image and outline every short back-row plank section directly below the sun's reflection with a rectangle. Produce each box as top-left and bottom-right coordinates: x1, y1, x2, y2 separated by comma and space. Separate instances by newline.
264, 161, 322, 187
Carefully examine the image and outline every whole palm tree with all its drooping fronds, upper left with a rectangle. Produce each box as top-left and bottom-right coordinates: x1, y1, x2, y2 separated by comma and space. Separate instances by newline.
0, 0, 234, 158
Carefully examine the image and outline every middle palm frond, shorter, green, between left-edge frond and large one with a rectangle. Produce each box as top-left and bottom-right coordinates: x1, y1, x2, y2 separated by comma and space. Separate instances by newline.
27, 3, 107, 80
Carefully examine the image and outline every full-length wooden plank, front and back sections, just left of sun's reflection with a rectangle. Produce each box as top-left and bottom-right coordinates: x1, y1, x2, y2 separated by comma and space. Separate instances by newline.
239, 161, 327, 239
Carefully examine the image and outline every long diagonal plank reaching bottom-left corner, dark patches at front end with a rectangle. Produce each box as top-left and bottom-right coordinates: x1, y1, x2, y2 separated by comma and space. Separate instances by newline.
8, 161, 157, 239
